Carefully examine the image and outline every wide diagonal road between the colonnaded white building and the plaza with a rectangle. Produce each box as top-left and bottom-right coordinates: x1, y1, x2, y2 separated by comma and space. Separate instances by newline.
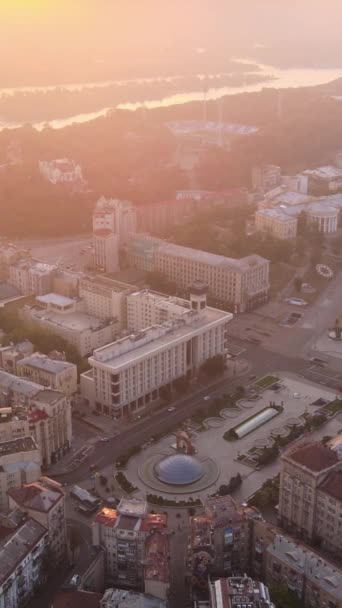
51, 345, 310, 485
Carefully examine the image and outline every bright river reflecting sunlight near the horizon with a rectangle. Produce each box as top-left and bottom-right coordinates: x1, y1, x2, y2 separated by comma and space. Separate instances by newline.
0, 58, 342, 131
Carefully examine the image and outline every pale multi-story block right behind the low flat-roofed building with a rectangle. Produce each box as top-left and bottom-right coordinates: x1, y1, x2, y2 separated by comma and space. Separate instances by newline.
79, 276, 137, 332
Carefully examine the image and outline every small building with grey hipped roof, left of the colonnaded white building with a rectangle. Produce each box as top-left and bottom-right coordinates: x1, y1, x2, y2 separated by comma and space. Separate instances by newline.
16, 353, 77, 397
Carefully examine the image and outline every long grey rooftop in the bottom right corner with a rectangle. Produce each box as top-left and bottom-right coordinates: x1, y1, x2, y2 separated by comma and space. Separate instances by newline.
267, 535, 342, 601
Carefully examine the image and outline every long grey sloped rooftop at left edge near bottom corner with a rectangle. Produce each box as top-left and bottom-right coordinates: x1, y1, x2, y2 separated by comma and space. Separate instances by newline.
0, 519, 47, 586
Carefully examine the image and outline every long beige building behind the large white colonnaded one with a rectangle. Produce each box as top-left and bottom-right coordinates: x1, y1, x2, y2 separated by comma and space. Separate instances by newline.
128, 235, 270, 313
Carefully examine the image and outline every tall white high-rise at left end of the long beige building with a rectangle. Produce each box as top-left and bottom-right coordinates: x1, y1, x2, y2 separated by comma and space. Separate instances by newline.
93, 196, 137, 247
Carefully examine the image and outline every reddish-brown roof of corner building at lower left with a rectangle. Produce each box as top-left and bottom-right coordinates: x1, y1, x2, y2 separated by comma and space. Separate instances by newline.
8, 481, 64, 513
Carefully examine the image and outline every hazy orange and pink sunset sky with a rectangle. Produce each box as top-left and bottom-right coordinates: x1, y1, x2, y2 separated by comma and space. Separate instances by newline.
0, 0, 342, 86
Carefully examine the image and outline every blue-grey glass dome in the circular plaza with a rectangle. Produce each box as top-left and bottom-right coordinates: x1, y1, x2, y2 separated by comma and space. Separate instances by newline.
154, 454, 203, 486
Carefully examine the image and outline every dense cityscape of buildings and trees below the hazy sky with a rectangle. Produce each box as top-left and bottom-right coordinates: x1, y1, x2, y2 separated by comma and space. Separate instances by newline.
0, 5, 342, 608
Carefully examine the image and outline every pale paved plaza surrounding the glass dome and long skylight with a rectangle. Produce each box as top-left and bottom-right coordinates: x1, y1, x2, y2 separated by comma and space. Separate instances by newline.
125, 373, 342, 500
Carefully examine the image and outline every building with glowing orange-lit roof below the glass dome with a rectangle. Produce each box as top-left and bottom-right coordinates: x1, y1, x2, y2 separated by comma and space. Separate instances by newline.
93, 498, 167, 590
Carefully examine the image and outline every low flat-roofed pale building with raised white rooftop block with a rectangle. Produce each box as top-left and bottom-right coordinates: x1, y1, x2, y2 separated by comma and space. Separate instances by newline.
21, 293, 118, 357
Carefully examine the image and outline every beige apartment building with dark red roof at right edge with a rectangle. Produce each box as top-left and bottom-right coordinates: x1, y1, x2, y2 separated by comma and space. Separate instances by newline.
279, 442, 342, 555
